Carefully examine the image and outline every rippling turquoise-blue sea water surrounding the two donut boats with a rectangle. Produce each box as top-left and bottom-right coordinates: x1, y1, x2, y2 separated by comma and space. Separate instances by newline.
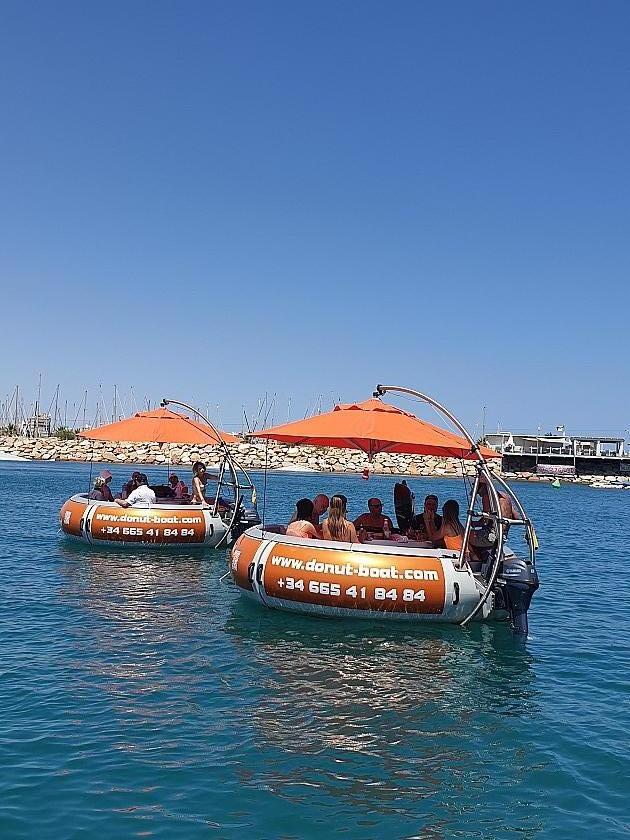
0, 463, 630, 840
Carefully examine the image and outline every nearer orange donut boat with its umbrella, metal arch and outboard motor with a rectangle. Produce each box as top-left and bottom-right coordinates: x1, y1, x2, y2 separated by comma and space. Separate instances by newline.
230, 385, 538, 634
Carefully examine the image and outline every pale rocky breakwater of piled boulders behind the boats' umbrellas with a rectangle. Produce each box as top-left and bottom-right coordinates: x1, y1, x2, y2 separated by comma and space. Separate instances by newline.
0, 436, 500, 476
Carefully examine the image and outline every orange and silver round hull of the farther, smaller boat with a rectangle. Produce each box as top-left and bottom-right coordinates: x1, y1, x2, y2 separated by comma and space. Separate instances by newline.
59, 494, 227, 549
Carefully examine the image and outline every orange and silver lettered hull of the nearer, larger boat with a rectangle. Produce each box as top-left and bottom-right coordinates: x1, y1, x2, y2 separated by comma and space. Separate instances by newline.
231, 527, 507, 624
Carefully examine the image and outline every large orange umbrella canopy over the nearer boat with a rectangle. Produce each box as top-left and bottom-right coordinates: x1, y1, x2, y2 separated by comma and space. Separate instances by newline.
254, 399, 500, 460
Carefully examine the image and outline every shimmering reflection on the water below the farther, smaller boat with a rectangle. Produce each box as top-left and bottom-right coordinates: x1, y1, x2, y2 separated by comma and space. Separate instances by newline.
57, 545, 222, 728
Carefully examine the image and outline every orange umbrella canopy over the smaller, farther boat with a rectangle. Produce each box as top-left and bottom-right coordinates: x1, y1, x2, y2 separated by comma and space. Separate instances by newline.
79, 408, 238, 446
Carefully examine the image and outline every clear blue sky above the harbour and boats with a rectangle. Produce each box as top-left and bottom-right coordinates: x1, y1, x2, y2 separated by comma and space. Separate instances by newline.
0, 0, 630, 440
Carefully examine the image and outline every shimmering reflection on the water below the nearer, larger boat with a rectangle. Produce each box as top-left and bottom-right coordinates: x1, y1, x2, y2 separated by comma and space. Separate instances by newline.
225, 602, 537, 837
